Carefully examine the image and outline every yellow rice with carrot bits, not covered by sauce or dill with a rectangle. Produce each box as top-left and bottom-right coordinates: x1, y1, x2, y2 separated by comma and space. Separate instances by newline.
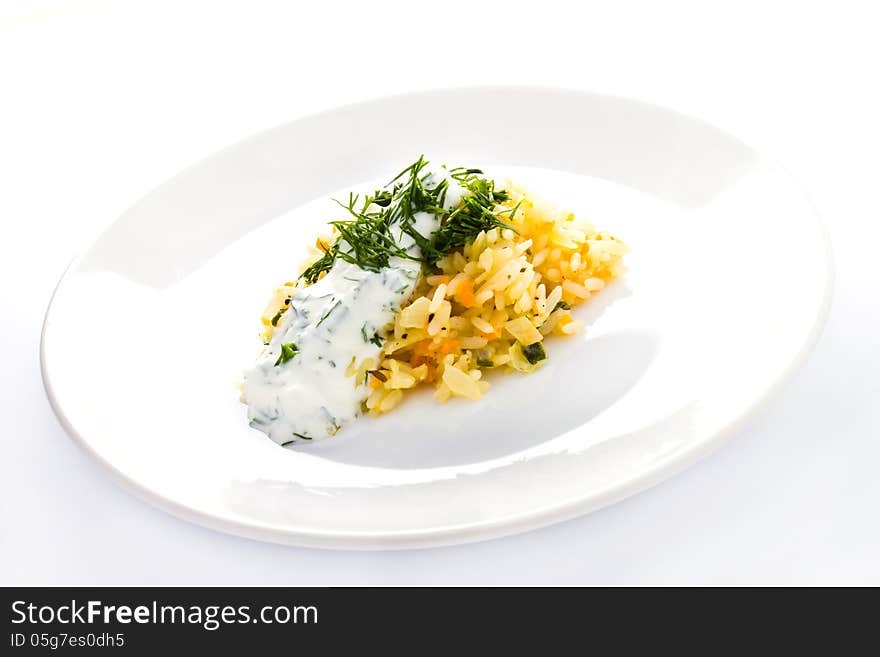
262, 179, 627, 415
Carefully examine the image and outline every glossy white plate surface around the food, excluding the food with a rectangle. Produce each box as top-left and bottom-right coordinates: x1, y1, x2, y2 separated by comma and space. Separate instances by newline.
42, 88, 831, 548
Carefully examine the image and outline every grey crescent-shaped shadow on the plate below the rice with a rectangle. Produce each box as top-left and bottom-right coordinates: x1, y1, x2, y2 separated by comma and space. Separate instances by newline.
308, 322, 658, 469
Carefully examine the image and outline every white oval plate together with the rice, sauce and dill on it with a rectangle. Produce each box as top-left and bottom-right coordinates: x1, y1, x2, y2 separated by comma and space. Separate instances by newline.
40, 87, 833, 549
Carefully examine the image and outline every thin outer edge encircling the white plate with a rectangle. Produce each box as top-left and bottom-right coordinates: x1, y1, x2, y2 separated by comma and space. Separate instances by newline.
40, 84, 836, 550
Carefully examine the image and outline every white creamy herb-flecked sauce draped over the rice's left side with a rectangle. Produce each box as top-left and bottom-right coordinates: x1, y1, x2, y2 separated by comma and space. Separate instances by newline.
242, 170, 466, 445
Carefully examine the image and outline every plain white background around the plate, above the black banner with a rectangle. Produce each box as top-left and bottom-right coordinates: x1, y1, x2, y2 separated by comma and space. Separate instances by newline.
0, 0, 880, 584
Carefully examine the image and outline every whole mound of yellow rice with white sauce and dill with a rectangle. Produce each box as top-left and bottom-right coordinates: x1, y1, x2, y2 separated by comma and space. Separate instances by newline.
242, 157, 626, 447
